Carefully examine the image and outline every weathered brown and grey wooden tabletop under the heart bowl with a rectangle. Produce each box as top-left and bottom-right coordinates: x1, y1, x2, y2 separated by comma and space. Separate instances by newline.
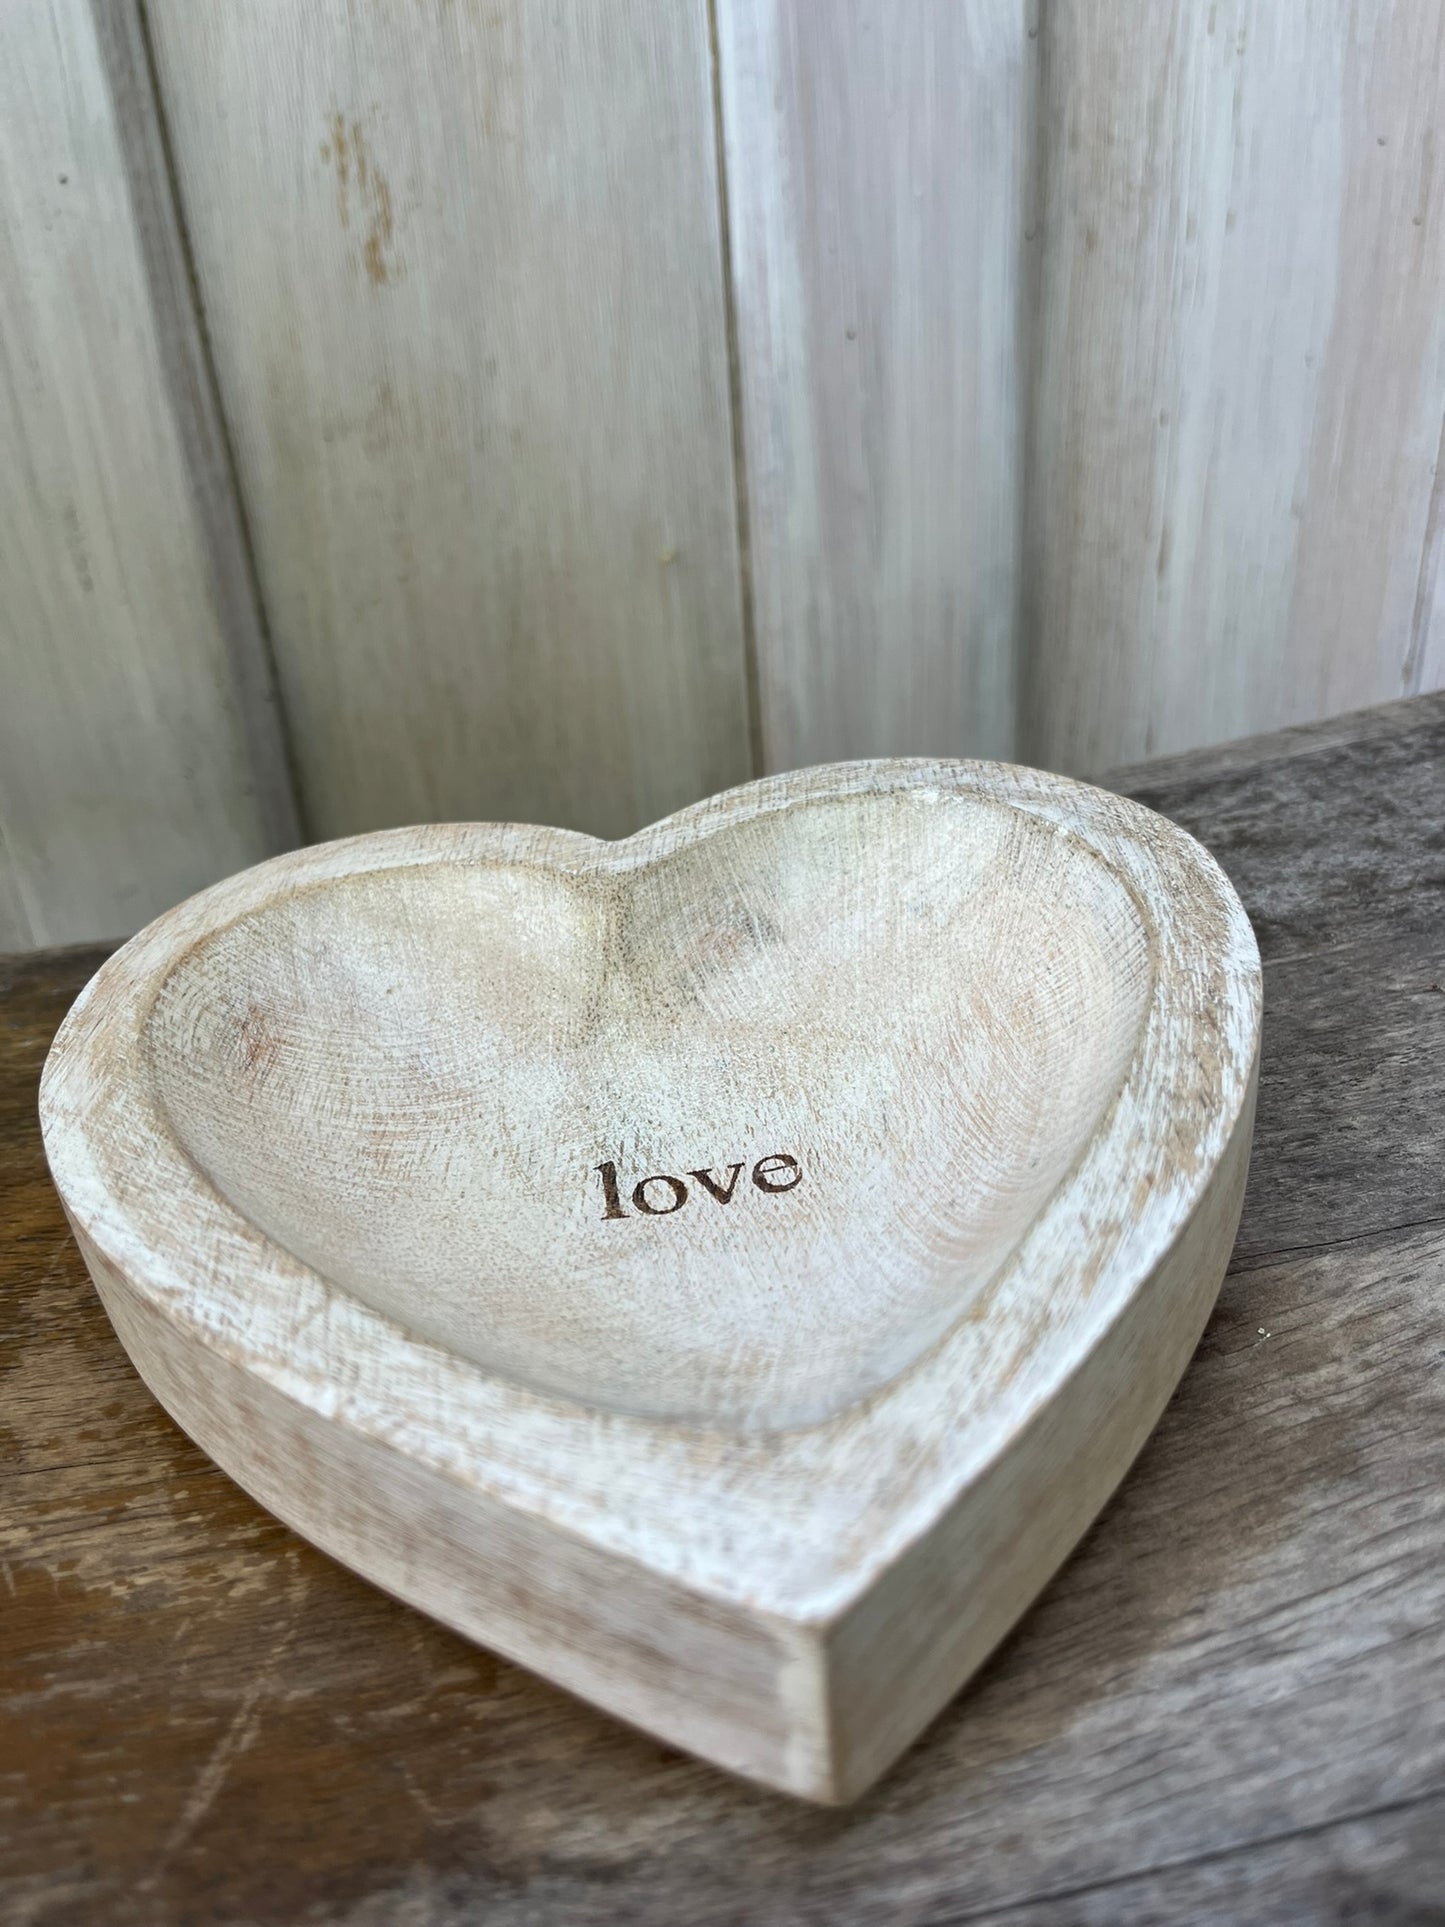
0, 698, 1445, 1927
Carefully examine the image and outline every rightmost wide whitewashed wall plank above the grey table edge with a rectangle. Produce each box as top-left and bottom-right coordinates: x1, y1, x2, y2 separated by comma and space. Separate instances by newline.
1021, 0, 1445, 771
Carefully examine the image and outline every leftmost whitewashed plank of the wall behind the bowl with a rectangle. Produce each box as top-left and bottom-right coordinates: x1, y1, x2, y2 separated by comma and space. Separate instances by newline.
0, 0, 274, 948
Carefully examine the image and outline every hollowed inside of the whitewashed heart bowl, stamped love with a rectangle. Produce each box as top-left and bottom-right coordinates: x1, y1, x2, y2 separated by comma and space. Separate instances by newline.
146, 788, 1154, 1430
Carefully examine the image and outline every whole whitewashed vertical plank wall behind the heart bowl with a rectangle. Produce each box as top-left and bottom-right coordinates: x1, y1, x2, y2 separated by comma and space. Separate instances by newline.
0, 0, 1445, 948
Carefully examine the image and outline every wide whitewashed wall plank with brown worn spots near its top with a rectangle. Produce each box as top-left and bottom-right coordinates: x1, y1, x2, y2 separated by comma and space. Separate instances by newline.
150, 0, 749, 834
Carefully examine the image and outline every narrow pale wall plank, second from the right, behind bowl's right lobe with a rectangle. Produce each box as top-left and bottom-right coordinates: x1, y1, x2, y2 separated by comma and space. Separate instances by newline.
717, 0, 1033, 767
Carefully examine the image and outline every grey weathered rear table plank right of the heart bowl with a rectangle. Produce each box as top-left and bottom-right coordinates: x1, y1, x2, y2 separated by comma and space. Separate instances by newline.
1117, 696, 1445, 1264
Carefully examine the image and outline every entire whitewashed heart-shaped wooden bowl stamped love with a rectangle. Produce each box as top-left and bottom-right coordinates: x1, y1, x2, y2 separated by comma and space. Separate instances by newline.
40, 761, 1260, 1800
